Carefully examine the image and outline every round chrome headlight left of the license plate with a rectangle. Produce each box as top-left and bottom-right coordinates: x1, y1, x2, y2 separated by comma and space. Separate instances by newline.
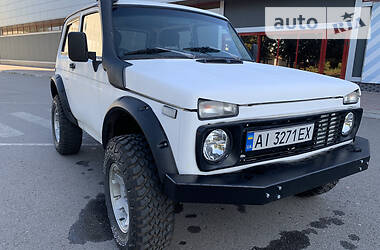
203, 129, 230, 162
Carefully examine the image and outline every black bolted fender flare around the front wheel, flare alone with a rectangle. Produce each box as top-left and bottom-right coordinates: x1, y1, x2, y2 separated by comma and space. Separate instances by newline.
102, 96, 178, 180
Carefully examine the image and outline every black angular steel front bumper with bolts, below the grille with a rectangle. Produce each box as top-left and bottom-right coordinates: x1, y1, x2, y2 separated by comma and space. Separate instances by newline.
164, 137, 370, 205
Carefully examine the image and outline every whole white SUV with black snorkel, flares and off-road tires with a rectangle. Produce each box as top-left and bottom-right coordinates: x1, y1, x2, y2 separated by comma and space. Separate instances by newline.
51, 0, 370, 249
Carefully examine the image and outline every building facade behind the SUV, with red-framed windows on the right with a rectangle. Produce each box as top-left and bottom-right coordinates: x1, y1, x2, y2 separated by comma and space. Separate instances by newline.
0, 0, 380, 89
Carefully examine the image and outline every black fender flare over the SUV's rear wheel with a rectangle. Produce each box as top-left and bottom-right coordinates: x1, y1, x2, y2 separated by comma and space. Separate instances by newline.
50, 75, 78, 126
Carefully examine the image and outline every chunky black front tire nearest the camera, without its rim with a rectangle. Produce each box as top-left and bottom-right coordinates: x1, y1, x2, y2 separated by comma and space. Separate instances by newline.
104, 134, 174, 250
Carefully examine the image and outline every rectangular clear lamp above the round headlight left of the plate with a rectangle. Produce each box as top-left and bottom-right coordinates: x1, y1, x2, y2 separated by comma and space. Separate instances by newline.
198, 100, 239, 119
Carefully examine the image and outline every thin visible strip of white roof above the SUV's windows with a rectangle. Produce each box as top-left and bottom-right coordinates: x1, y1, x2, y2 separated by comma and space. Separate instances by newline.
65, 0, 227, 21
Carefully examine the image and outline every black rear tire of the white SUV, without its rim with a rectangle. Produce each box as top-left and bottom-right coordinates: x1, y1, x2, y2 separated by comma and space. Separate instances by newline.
51, 96, 83, 155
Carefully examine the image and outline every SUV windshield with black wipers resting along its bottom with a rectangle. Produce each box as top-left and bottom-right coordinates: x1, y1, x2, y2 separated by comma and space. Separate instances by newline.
113, 6, 252, 60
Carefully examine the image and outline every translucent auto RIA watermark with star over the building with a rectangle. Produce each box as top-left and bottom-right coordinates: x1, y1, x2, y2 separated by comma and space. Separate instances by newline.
265, 7, 371, 39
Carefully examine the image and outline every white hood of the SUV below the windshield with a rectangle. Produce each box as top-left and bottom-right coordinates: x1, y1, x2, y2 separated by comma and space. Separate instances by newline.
125, 59, 358, 109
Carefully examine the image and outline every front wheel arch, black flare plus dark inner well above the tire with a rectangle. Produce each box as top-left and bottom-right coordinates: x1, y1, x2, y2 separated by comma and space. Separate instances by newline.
102, 96, 178, 180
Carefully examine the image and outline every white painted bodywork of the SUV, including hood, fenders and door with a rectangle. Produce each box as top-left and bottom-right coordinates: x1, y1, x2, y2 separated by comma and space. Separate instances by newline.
56, 1, 360, 175
